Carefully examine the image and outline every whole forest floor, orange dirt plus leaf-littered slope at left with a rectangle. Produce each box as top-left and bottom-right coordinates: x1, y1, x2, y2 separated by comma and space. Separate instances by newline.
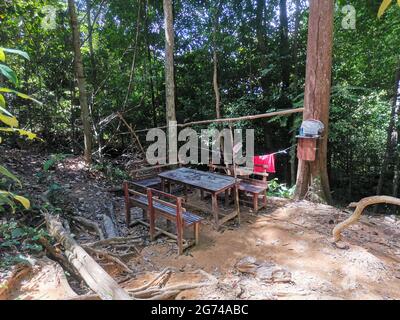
0, 149, 400, 299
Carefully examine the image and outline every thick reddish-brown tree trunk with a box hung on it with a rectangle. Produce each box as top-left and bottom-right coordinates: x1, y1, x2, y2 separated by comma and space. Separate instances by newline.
296, 0, 334, 203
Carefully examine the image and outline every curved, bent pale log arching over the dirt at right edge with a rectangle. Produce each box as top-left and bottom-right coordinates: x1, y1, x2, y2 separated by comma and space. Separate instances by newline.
332, 196, 400, 242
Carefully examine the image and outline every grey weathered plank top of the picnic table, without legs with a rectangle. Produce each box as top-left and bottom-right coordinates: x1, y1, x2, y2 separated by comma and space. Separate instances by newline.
159, 168, 235, 192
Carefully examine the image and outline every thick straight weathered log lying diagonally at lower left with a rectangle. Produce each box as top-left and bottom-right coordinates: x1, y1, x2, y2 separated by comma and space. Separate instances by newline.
44, 213, 131, 300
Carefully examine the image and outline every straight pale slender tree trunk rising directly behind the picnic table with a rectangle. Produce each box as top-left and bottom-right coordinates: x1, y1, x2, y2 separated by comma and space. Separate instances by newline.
163, 0, 177, 163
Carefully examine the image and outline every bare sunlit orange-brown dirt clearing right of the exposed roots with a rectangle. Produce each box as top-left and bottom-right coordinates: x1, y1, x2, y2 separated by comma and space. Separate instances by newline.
124, 200, 400, 299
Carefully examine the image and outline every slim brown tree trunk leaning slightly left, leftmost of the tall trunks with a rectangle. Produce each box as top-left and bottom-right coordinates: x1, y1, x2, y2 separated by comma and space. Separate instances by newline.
68, 0, 92, 164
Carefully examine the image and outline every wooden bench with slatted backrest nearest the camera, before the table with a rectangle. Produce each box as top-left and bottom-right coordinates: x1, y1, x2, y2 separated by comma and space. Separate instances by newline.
123, 182, 203, 255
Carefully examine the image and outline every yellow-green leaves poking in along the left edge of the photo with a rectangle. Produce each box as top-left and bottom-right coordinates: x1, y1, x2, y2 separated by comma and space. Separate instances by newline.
0, 47, 40, 212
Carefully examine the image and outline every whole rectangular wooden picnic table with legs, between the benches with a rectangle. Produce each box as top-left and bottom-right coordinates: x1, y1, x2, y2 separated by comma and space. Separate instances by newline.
158, 168, 240, 230
